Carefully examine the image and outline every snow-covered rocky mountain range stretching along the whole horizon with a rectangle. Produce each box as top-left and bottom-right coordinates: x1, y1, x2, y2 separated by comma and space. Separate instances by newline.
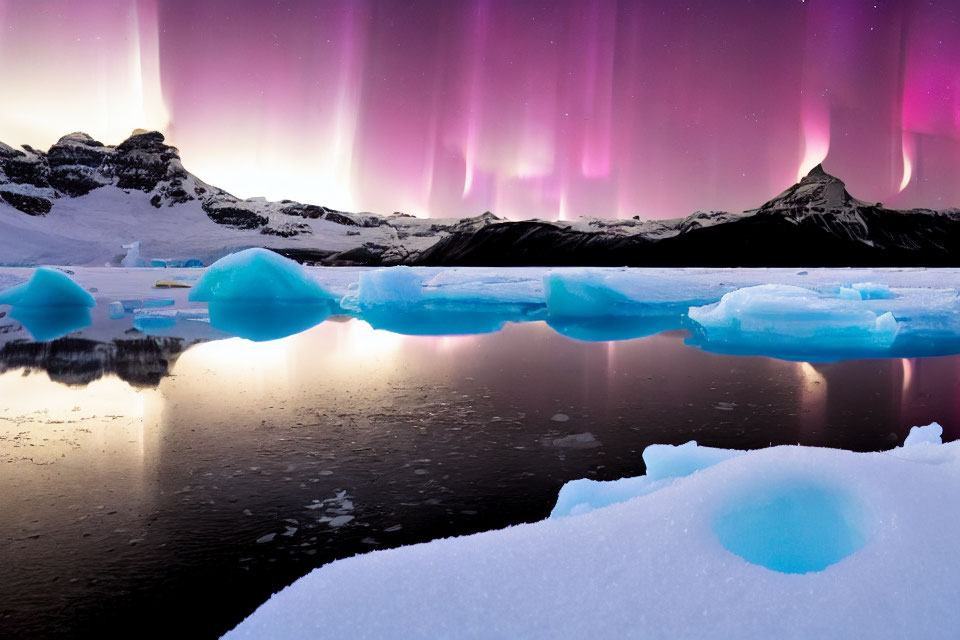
0, 130, 960, 266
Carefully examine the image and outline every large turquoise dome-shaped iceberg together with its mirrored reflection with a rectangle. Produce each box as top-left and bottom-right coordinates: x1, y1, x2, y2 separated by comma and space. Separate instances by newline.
189, 249, 339, 342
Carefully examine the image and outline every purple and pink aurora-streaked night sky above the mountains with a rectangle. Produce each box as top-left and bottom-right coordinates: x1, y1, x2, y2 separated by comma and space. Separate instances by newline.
0, 0, 960, 219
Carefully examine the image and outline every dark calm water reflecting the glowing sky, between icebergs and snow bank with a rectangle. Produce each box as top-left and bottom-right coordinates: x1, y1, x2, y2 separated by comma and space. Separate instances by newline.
0, 321, 960, 638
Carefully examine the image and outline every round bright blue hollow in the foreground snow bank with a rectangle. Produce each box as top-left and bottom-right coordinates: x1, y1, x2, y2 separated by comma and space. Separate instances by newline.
711, 476, 875, 573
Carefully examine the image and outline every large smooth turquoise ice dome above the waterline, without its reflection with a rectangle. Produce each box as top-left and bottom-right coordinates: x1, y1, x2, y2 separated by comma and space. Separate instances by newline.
189, 248, 332, 302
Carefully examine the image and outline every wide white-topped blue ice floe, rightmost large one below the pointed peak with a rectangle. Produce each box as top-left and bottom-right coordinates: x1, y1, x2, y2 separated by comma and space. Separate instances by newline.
689, 284, 900, 360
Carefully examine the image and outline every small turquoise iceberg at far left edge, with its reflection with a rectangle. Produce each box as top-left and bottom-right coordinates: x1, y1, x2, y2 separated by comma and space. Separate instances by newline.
0, 267, 96, 341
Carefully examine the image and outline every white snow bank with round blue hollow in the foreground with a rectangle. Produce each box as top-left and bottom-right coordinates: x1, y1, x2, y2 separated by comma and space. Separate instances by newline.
225, 425, 960, 640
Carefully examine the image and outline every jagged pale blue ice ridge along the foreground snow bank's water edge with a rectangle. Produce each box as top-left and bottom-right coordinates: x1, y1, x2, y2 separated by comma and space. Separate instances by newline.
550, 440, 746, 518
